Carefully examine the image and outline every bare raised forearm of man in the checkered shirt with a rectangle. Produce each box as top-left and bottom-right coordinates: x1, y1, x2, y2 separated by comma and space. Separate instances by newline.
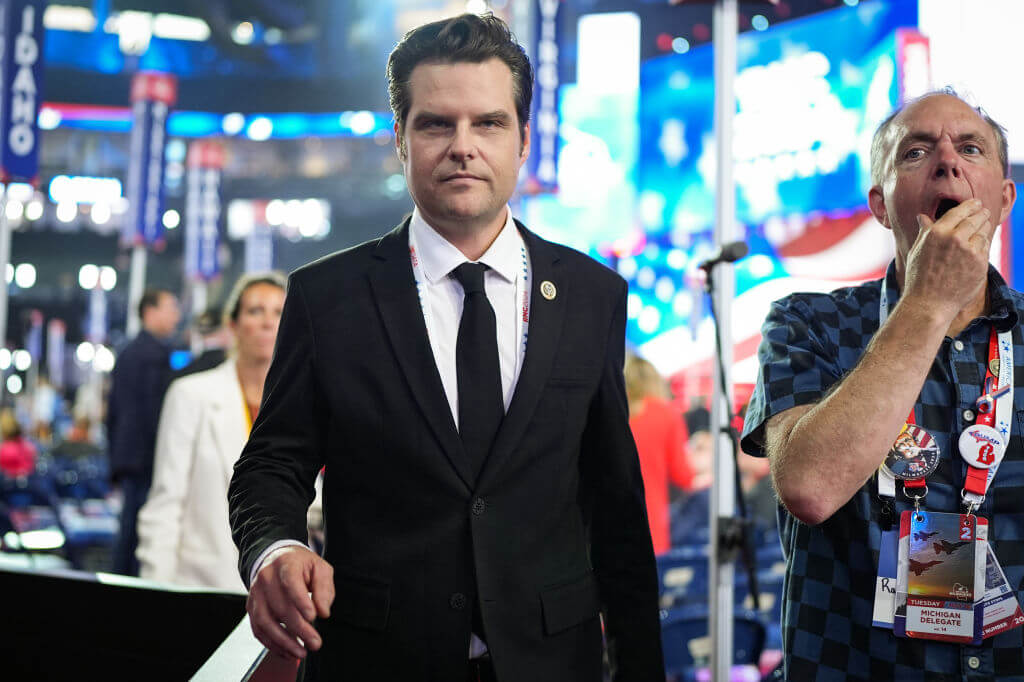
765, 299, 949, 524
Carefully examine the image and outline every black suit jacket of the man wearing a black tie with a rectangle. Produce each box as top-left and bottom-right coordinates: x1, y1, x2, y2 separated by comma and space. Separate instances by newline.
228, 221, 665, 682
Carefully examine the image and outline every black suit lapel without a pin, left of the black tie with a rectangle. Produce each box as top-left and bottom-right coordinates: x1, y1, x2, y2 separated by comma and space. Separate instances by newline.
370, 220, 474, 489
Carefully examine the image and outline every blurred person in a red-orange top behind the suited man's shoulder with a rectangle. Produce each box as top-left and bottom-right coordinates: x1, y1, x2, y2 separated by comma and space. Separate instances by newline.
625, 354, 693, 554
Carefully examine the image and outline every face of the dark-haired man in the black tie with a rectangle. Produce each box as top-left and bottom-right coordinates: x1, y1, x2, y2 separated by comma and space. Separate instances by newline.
395, 57, 529, 240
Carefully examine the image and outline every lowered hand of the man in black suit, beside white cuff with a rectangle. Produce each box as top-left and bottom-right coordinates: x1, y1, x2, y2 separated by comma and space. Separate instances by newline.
246, 545, 334, 658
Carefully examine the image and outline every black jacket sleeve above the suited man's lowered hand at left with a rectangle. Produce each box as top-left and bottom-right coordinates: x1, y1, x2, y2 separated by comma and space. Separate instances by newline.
227, 273, 326, 586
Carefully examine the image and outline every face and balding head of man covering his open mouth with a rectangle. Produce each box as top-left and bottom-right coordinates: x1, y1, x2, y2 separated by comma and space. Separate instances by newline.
868, 94, 1016, 264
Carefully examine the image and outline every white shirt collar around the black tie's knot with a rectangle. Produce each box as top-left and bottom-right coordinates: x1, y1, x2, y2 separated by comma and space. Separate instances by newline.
409, 207, 522, 284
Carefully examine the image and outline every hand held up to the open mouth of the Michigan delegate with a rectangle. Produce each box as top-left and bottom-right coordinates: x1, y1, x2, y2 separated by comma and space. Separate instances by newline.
904, 199, 996, 318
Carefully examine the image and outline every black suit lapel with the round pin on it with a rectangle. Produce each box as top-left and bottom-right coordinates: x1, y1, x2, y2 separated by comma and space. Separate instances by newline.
479, 221, 569, 485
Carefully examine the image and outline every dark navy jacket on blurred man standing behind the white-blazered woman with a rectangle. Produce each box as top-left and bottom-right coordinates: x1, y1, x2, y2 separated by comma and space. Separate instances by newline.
106, 330, 171, 480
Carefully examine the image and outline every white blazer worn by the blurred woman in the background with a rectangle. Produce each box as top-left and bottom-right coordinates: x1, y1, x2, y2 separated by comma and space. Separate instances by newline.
135, 359, 249, 592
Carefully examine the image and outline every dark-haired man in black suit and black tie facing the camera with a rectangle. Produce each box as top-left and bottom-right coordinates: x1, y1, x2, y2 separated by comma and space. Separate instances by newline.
228, 14, 665, 682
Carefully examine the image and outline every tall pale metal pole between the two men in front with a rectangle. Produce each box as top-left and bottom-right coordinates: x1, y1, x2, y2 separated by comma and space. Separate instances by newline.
709, 0, 739, 682
